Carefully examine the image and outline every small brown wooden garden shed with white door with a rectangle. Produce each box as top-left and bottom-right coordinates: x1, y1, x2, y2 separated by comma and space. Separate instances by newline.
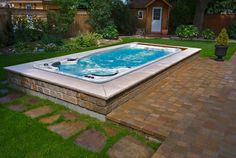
130, 0, 171, 35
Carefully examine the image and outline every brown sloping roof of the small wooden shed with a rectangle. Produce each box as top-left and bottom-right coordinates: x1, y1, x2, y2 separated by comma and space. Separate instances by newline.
130, 0, 171, 9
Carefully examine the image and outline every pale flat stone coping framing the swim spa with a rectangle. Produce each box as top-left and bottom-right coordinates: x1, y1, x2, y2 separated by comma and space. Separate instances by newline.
5, 42, 201, 100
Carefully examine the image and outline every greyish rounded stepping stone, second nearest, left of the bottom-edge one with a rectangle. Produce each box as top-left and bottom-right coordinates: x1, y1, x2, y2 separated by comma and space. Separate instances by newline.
75, 129, 106, 152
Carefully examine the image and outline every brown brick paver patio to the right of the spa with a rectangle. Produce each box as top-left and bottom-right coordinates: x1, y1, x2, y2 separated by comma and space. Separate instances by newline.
108, 56, 236, 158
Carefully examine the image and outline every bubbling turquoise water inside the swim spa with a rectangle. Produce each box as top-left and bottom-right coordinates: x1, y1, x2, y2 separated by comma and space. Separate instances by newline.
58, 47, 170, 76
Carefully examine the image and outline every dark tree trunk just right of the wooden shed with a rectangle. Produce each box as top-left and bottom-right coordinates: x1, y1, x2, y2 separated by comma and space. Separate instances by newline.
193, 0, 210, 30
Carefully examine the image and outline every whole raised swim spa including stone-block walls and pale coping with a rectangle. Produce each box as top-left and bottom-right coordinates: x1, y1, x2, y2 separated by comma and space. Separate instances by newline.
5, 43, 200, 120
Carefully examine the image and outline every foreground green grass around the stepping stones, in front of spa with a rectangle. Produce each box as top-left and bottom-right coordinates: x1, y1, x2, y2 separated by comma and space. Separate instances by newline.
0, 95, 160, 158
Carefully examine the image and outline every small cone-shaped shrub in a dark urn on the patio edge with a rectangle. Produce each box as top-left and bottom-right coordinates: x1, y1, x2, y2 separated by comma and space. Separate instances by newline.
215, 28, 229, 61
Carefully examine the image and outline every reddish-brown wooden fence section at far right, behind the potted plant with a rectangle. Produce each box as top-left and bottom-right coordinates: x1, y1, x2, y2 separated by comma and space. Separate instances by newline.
204, 14, 236, 33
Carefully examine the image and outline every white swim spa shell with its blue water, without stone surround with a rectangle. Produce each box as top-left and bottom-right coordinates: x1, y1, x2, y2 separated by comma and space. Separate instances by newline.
34, 44, 181, 83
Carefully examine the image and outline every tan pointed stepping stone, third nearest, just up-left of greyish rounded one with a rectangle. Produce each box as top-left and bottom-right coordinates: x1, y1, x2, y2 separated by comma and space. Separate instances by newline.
48, 122, 87, 138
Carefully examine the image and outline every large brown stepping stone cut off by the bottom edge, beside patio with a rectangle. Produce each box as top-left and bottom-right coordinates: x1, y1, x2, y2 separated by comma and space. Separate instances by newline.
108, 136, 154, 158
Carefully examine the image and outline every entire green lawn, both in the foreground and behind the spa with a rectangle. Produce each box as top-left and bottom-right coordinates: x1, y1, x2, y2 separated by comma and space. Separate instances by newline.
0, 38, 236, 158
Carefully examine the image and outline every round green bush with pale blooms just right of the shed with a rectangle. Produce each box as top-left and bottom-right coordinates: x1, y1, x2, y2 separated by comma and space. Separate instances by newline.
175, 25, 199, 39
